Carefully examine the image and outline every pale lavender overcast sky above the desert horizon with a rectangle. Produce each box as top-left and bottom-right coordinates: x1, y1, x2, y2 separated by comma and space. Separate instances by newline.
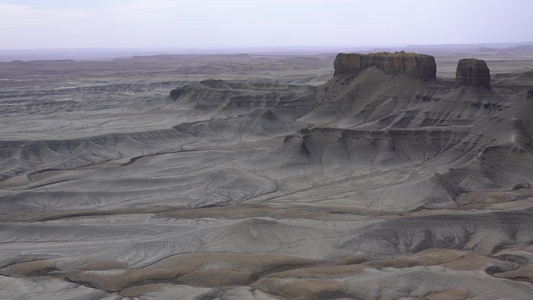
0, 0, 533, 49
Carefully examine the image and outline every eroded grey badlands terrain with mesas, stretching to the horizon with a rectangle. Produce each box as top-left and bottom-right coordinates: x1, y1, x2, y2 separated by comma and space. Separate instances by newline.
0, 49, 533, 300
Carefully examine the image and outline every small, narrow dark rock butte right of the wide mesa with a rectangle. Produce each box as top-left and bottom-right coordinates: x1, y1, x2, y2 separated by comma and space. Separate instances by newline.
455, 58, 490, 90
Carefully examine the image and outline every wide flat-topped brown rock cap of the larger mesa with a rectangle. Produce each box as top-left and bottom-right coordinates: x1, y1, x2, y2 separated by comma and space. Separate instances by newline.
333, 51, 437, 80
